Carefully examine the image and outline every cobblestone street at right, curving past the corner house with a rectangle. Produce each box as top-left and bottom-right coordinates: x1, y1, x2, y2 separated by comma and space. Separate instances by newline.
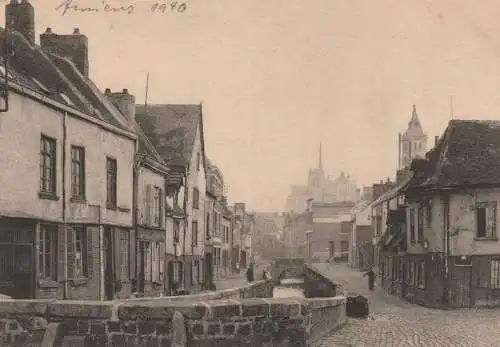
314, 264, 500, 347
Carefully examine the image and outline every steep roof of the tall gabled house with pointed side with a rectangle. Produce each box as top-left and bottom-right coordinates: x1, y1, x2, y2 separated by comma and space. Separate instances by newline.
136, 105, 203, 166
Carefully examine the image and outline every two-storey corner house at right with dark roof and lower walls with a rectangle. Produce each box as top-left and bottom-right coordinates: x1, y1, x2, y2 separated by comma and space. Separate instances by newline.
376, 120, 500, 307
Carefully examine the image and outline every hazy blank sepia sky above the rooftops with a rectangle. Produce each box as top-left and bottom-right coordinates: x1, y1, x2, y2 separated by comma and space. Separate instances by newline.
8, 0, 500, 210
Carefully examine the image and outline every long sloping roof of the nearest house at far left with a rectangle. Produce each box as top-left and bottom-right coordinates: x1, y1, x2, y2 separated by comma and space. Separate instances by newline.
0, 28, 131, 131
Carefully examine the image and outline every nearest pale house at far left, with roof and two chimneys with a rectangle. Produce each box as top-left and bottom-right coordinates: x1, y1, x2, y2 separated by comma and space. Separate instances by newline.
0, 1, 138, 299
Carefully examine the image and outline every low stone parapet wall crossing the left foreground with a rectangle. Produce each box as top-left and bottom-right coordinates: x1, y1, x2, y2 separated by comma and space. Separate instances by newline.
0, 266, 346, 347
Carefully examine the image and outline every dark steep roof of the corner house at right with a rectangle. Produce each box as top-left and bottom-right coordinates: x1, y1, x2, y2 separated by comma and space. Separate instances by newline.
410, 120, 500, 188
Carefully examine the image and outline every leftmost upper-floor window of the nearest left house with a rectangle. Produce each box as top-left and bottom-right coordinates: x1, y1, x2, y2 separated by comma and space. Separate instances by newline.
39, 134, 57, 196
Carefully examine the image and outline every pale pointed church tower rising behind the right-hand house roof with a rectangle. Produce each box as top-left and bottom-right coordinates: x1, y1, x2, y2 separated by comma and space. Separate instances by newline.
398, 105, 427, 170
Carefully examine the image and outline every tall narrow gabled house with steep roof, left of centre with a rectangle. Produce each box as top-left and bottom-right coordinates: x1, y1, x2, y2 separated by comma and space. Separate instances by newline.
135, 104, 207, 292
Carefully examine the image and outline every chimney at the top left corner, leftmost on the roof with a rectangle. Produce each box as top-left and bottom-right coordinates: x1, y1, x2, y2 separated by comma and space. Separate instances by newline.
5, 0, 35, 45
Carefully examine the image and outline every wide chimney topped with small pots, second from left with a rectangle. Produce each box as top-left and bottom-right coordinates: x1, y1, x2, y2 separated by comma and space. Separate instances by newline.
40, 28, 89, 77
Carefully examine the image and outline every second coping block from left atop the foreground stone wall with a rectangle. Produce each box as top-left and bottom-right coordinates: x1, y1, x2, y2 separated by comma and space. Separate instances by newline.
47, 300, 114, 319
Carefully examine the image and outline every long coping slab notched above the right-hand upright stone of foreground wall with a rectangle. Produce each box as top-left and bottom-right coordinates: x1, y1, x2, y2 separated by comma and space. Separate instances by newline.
118, 301, 208, 321
